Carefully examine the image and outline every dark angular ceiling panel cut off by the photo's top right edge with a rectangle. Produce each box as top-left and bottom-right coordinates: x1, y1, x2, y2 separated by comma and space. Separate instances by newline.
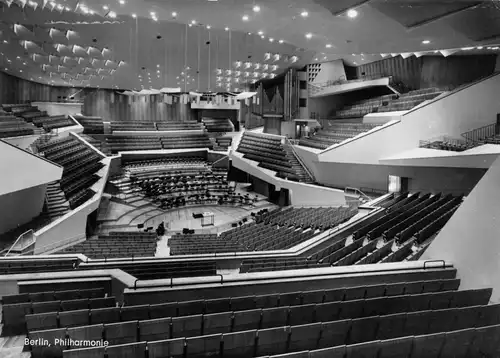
370, 0, 481, 28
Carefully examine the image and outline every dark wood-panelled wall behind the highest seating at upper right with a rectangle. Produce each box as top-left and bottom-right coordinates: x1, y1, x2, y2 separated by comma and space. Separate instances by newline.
356, 55, 497, 89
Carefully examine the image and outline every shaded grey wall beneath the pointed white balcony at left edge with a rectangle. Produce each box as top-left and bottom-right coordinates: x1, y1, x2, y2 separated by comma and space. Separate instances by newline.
0, 184, 47, 234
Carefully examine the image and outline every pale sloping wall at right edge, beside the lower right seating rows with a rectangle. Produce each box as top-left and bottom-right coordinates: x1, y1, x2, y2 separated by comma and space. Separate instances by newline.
421, 158, 500, 303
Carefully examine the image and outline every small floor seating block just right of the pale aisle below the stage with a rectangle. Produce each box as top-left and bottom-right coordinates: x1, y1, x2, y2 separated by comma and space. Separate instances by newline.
168, 234, 244, 255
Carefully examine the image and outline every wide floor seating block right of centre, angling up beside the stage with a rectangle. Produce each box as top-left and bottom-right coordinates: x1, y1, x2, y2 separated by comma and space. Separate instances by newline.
207, 207, 356, 253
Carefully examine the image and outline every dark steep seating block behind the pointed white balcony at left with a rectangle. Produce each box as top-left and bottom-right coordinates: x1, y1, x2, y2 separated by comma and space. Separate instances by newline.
38, 136, 103, 209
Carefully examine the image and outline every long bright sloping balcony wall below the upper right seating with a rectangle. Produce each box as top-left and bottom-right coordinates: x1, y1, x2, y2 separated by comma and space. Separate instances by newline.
319, 74, 500, 164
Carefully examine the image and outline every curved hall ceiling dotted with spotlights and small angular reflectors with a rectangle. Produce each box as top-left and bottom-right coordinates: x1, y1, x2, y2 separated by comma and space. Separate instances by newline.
0, 0, 500, 91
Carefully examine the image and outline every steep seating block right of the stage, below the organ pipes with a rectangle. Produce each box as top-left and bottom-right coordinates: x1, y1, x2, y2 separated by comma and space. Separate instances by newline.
238, 131, 300, 181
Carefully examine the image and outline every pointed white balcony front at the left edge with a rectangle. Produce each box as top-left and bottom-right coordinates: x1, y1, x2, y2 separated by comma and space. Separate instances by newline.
0, 140, 63, 195
